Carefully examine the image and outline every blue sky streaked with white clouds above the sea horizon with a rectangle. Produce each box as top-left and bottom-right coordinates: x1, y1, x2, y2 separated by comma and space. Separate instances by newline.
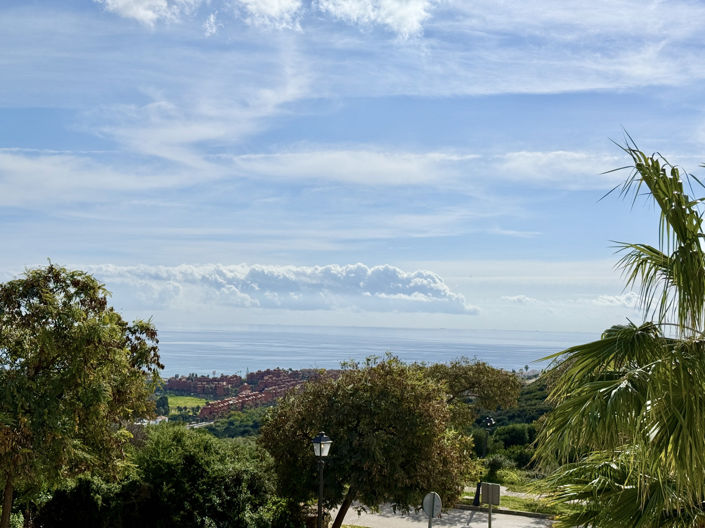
0, 0, 705, 333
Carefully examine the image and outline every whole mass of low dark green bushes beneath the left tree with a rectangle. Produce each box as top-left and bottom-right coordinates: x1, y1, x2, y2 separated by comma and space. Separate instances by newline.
39, 424, 273, 528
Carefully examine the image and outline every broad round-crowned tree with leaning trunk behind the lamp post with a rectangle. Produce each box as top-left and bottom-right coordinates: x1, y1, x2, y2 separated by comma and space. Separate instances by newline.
260, 357, 472, 528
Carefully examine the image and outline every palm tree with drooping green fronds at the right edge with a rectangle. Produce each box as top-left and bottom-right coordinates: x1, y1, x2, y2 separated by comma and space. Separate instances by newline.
537, 138, 705, 528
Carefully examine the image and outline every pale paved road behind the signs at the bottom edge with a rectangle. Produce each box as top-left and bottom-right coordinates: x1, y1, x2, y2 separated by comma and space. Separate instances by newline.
332, 506, 551, 528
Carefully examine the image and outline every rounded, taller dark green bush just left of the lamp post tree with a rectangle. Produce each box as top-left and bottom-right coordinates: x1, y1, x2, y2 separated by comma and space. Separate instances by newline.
126, 424, 273, 528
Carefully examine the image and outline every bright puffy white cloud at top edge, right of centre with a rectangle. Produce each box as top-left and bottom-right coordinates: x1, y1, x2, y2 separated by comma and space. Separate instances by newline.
318, 0, 435, 38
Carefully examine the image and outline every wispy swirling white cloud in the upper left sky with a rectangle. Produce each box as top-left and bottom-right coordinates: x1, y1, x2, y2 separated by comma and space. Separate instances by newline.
93, 46, 309, 167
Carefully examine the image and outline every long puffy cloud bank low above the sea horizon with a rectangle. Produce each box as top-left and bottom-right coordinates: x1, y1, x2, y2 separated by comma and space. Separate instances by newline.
86, 264, 477, 314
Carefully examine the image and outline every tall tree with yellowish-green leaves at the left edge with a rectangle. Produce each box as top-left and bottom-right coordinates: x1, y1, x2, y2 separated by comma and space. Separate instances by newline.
0, 264, 161, 528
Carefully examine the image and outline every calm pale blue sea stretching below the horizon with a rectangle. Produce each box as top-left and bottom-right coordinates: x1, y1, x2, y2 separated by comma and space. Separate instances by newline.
159, 325, 599, 378
